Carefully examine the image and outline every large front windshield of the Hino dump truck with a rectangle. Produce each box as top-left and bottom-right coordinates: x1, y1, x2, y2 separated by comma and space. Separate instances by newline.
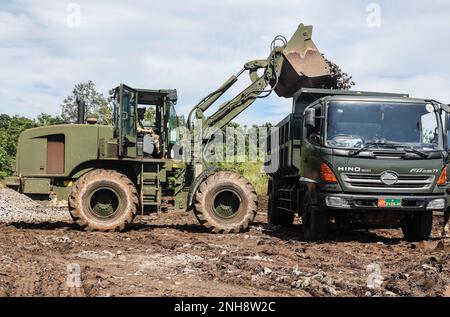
326, 101, 443, 151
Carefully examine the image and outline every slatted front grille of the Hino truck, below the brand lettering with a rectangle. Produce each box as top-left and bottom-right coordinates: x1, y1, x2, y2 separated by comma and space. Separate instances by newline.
341, 174, 436, 191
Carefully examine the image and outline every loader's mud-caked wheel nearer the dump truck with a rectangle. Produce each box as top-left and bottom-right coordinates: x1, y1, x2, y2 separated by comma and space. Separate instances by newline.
194, 172, 258, 233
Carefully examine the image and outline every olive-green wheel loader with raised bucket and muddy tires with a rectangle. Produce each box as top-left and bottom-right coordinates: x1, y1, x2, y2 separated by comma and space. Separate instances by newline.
8, 24, 331, 233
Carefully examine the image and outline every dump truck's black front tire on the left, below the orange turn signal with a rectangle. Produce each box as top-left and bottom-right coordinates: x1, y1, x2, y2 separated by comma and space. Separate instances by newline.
302, 194, 330, 242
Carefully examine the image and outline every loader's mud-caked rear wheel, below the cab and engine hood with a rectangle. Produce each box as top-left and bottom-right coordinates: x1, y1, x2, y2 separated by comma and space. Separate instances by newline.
69, 170, 139, 231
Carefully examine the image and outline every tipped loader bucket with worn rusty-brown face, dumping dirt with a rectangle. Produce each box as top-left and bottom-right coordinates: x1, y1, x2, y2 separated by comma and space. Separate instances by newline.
275, 24, 331, 98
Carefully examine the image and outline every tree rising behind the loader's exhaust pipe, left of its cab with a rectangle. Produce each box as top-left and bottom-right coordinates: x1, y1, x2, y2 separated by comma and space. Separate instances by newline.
61, 80, 113, 124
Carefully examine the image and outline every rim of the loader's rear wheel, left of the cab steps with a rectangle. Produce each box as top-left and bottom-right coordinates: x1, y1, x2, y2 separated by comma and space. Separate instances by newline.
88, 187, 120, 218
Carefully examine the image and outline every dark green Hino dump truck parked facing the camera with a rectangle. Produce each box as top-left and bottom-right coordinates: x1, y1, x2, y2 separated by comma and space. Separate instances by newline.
265, 89, 449, 241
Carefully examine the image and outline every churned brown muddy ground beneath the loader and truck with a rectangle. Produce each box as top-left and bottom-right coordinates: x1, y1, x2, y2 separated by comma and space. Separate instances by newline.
0, 185, 450, 297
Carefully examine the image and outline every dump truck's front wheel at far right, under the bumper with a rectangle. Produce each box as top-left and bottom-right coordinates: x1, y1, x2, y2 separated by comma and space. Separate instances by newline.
402, 211, 433, 242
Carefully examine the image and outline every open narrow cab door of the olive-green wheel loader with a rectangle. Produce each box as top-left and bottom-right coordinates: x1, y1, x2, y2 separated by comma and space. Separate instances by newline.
118, 85, 137, 158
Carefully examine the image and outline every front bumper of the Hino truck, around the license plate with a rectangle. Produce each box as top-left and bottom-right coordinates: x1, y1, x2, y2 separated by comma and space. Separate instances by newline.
318, 193, 447, 211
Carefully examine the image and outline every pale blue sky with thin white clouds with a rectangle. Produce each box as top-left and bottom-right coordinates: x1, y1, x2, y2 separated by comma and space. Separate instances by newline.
0, 0, 450, 125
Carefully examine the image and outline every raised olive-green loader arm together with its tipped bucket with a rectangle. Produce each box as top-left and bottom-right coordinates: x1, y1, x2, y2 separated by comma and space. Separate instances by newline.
188, 24, 331, 130
